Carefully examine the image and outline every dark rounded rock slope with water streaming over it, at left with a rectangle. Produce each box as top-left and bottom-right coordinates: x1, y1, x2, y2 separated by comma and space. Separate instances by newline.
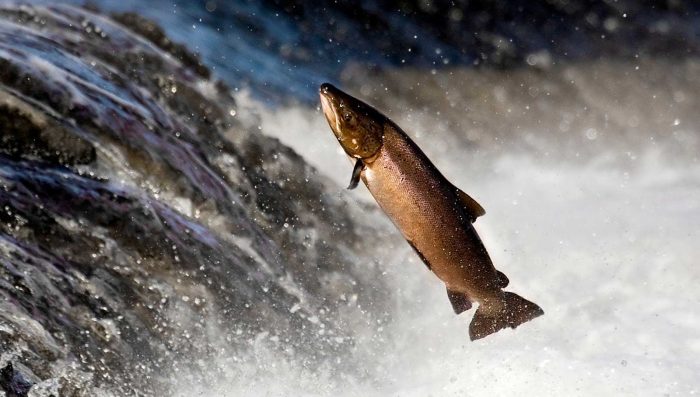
0, 5, 385, 395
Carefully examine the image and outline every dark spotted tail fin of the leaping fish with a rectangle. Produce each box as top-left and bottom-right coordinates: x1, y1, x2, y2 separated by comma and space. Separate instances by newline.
469, 292, 544, 340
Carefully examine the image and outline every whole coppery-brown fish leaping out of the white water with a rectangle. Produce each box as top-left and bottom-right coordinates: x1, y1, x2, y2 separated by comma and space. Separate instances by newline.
320, 83, 544, 340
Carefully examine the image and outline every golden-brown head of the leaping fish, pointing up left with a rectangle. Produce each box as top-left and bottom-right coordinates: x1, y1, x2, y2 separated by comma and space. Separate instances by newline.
319, 83, 388, 160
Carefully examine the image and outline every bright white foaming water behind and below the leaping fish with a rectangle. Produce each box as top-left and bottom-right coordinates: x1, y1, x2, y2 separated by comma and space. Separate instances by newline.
171, 59, 700, 396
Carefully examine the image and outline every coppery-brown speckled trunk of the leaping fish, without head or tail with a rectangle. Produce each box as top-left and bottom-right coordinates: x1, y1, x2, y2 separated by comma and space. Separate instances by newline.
362, 126, 502, 302
